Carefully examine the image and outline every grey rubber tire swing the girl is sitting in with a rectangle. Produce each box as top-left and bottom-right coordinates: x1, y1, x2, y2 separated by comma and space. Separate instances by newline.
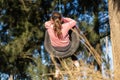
44, 27, 80, 58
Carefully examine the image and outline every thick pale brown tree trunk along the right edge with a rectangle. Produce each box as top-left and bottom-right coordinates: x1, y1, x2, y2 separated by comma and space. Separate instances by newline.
108, 0, 120, 80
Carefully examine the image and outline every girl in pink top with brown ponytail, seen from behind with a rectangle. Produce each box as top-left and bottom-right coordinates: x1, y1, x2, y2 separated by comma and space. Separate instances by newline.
45, 12, 79, 77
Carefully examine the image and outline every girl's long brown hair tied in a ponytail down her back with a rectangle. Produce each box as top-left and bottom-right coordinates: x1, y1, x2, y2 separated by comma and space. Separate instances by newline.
52, 12, 62, 39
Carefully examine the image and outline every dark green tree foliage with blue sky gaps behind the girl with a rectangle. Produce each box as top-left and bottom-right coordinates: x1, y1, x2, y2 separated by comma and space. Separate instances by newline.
0, 0, 108, 80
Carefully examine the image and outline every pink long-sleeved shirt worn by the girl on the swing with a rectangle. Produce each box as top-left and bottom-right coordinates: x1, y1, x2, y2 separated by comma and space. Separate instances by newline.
45, 18, 76, 47
